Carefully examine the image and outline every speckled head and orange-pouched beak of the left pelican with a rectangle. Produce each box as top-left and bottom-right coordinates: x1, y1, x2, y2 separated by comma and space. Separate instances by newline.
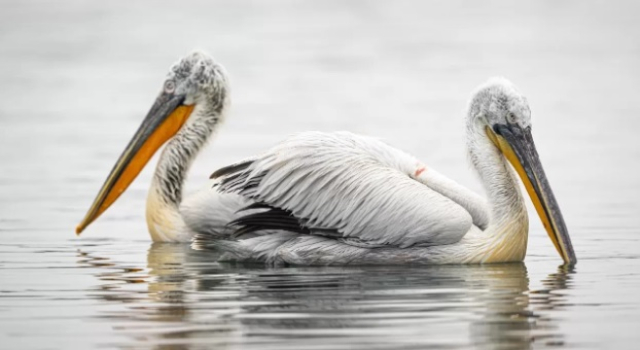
76, 52, 228, 234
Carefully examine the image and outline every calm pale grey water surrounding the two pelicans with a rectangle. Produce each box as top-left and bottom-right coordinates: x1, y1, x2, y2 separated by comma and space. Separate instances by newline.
0, 0, 640, 349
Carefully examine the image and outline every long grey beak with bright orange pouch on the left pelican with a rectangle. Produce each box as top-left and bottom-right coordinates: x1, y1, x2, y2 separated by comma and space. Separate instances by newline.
76, 93, 193, 235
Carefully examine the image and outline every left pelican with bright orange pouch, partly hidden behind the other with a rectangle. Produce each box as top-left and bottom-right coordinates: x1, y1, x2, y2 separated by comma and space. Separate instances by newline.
76, 52, 250, 242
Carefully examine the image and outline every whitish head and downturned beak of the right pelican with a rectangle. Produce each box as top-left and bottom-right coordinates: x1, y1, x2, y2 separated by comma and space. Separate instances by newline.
467, 78, 577, 264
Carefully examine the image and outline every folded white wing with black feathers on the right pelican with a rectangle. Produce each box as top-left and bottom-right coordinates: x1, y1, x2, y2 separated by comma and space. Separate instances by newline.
213, 132, 472, 248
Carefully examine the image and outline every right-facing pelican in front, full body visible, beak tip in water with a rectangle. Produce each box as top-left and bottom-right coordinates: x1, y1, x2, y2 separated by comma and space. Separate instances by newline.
192, 78, 577, 265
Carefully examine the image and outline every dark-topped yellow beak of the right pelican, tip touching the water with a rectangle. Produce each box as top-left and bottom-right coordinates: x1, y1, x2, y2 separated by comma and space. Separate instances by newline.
487, 124, 578, 265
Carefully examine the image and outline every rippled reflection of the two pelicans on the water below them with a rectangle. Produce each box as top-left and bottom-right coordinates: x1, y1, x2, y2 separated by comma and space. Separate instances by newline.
79, 243, 573, 349
